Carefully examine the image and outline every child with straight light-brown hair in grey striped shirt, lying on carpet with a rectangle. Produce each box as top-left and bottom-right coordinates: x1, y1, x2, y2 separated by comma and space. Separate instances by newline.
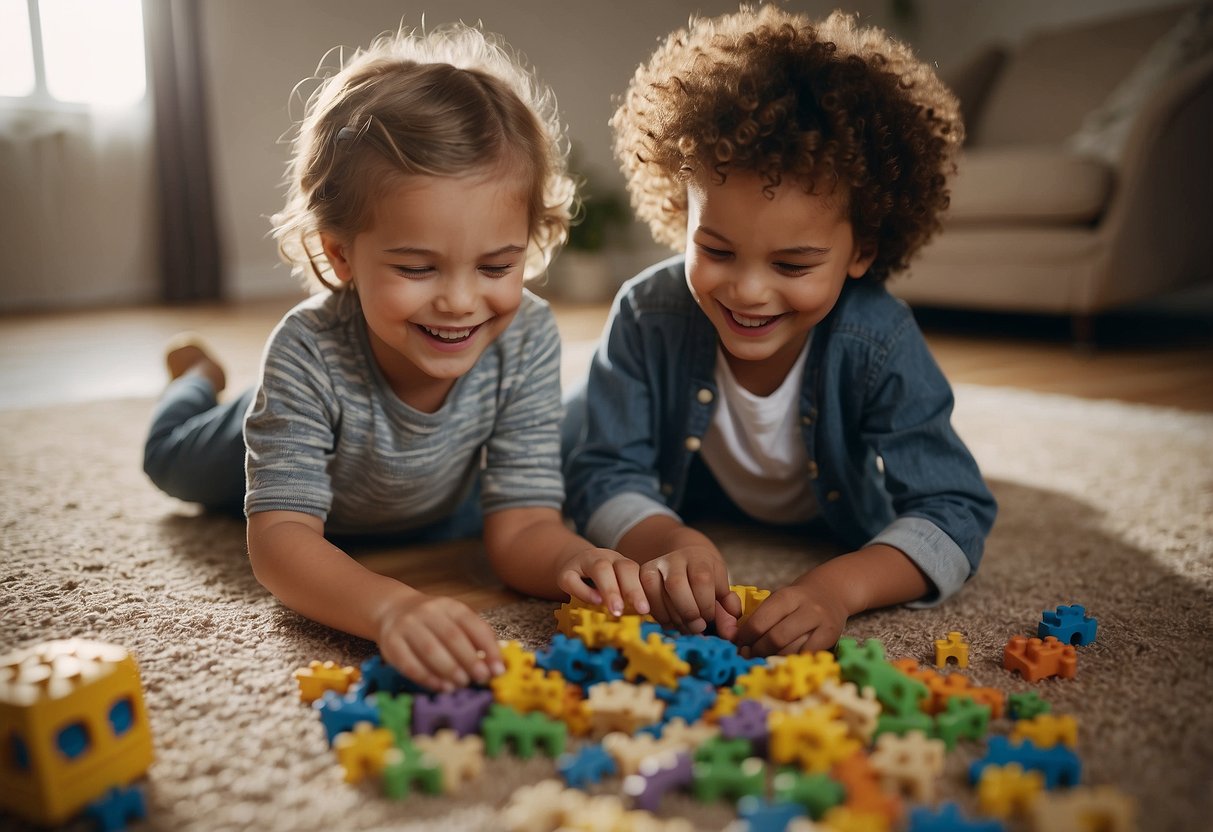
144, 25, 644, 689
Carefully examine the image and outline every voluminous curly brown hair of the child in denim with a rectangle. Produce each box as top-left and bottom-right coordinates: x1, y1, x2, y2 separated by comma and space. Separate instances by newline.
611, 6, 964, 280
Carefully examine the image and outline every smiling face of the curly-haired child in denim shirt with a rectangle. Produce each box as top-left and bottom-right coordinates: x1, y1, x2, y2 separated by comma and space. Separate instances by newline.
687, 171, 875, 395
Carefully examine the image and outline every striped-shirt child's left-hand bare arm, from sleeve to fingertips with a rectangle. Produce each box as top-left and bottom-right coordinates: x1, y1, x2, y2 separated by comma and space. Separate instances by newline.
249, 511, 505, 690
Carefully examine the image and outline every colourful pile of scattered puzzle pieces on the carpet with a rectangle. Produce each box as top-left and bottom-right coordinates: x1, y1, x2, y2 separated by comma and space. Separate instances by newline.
295, 596, 1135, 832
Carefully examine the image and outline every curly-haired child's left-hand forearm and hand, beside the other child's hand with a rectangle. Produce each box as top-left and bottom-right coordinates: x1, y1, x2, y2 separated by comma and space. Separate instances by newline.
619, 514, 741, 639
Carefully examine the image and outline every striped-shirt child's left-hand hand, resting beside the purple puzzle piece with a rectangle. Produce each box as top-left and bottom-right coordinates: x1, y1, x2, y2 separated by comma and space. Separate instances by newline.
376, 593, 506, 691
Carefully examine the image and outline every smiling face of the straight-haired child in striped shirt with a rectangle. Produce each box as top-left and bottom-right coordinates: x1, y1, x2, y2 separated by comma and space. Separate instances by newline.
320, 170, 529, 411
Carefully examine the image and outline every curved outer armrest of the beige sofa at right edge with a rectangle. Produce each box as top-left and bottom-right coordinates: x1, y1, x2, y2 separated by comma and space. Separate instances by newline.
1080, 55, 1213, 312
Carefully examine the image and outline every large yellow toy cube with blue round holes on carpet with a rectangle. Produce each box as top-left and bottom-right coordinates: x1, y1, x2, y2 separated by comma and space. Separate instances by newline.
0, 639, 153, 826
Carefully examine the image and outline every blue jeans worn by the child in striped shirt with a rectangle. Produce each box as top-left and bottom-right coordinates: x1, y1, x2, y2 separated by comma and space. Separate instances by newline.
143, 375, 484, 543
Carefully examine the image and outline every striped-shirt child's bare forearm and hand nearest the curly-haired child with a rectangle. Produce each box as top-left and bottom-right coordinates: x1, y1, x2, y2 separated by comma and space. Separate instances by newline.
484, 507, 649, 615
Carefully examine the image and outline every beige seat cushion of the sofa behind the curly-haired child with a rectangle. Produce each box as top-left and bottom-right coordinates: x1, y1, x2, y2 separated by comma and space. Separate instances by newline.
944, 147, 1114, 226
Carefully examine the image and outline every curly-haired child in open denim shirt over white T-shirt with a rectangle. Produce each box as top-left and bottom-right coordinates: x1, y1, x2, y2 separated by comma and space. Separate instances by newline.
565, 6, 996, 655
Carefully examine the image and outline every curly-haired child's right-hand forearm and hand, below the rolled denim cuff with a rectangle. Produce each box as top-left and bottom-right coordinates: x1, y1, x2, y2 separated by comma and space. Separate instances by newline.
736, 543, 932, 656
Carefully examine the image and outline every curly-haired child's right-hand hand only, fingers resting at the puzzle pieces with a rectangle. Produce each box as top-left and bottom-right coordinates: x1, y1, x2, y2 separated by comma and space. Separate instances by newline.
735, 582, 847, 656
